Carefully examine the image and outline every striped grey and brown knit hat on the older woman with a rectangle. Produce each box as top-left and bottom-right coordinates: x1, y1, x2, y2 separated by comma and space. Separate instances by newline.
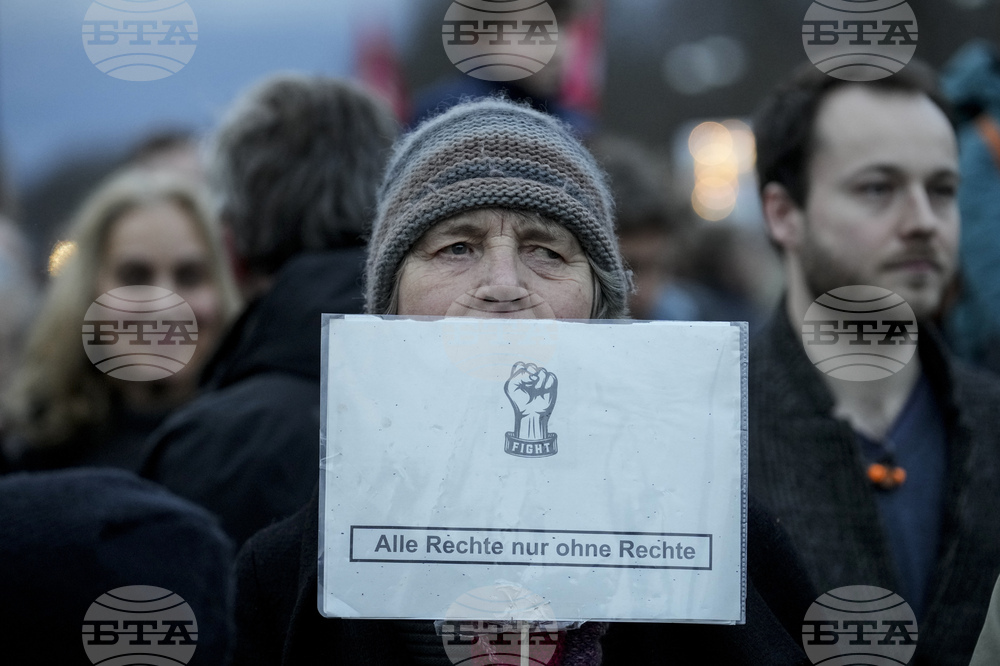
365, 98, 631, 318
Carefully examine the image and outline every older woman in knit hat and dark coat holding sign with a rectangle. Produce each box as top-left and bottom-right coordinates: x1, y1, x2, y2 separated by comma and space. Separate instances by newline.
235, 99, 815, 666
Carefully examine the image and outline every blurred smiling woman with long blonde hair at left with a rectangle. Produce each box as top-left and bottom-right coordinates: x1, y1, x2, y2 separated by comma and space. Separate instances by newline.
2, 169, 238, 470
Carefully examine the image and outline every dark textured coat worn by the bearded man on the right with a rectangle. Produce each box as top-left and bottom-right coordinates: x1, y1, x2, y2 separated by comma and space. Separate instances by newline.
749, 308, 1000, 666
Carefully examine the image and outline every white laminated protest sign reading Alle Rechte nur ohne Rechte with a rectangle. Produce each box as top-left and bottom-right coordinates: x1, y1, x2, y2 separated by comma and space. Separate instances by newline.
319, 315, 746, 623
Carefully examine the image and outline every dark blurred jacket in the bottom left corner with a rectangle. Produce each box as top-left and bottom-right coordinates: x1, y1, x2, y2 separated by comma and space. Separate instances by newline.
0, 469, 234, 666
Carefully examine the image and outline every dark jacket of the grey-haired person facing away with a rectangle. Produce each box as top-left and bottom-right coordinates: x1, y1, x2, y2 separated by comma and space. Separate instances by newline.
142, 249, 364, 545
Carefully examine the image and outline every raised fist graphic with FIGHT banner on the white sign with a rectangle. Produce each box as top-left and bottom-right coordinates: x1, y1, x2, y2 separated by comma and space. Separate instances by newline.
503, 361, 558, 458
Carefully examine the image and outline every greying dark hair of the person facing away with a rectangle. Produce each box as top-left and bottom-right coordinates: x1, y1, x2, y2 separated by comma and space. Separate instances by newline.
211, 74, 399, 275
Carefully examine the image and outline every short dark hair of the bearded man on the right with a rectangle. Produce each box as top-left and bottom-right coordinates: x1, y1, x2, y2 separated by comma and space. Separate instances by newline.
753, 60, 954, 207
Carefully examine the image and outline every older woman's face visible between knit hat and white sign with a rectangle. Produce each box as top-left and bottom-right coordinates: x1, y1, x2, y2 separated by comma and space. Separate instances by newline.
398, 210, 594, 319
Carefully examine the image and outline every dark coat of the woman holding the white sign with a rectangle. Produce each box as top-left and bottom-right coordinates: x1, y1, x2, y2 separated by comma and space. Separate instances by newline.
234, 494, 816, 666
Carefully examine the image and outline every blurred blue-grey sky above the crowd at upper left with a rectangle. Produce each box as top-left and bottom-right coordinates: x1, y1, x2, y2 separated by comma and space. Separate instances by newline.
0, 0, 422, 186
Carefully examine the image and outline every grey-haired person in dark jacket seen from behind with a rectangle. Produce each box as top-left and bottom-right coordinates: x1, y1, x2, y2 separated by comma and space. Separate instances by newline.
142, 74, 398, 544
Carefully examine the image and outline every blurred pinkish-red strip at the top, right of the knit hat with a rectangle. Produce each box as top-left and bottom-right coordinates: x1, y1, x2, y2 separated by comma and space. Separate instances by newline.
559, 0, 604, 117
